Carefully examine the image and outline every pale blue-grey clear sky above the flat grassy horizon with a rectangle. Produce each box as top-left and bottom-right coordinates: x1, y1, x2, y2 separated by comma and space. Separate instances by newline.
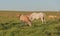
0, 0, 60, 11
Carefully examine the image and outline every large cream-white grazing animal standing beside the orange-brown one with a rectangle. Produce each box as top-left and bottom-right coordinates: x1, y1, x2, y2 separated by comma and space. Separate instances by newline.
29, 12, 46, 23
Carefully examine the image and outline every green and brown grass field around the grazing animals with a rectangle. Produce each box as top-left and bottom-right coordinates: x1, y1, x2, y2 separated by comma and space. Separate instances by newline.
0, 11, 60, 36
